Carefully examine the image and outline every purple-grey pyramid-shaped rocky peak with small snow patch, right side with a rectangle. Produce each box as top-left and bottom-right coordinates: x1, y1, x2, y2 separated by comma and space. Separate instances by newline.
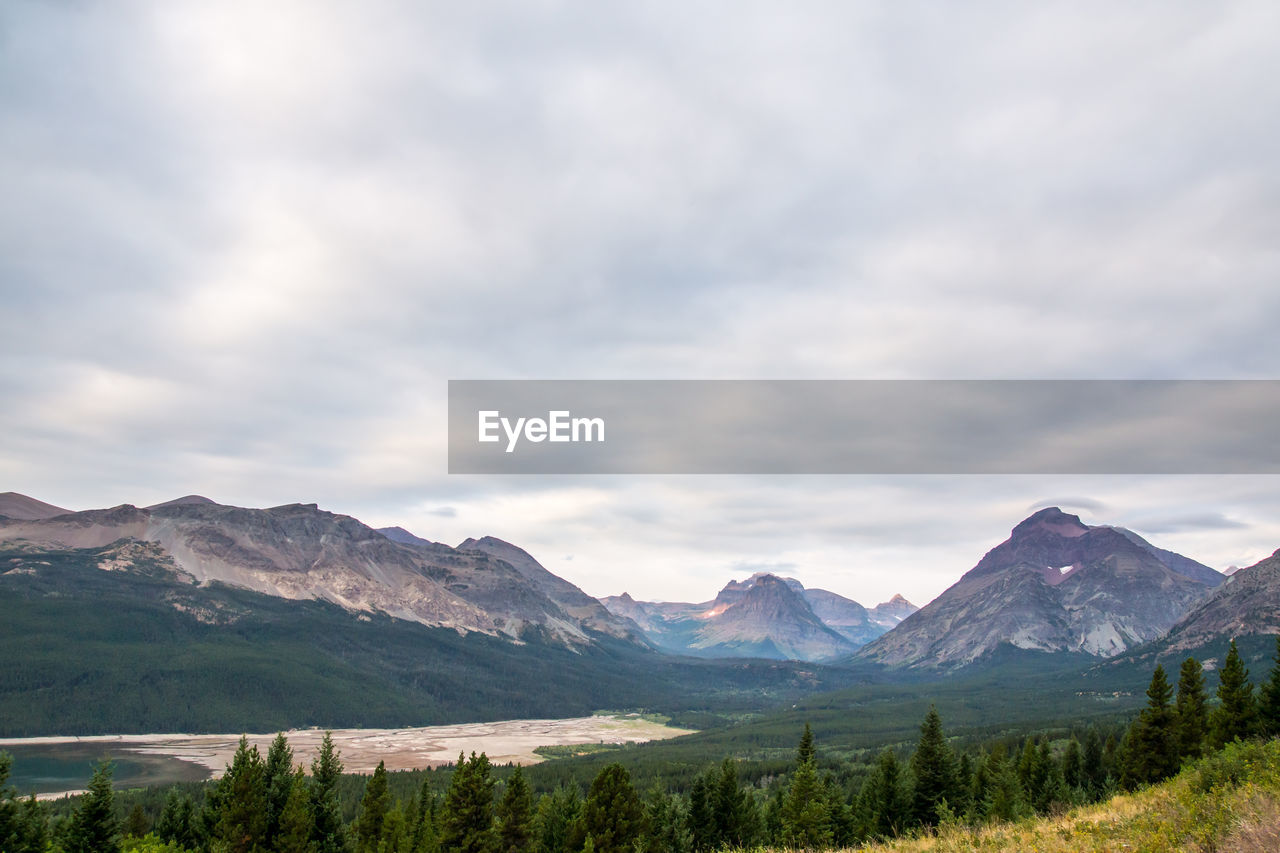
859, 507, 1221, 669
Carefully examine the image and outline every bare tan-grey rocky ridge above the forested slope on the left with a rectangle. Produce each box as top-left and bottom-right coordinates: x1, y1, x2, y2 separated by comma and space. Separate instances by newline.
0, 497, 640, 646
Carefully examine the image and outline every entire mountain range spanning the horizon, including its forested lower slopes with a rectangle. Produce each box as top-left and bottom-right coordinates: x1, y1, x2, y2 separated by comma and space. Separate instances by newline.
0, 492, 1280, 734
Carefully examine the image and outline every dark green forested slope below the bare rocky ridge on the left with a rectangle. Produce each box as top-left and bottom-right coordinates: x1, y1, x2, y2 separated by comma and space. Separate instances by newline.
0, 540, 851, 736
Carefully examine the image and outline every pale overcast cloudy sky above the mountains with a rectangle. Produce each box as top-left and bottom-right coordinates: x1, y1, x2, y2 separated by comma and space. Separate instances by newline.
0, 0, 1280, 605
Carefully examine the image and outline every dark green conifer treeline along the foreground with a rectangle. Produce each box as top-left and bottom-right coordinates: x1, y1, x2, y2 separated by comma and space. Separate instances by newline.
0, 638, 1280, 853
